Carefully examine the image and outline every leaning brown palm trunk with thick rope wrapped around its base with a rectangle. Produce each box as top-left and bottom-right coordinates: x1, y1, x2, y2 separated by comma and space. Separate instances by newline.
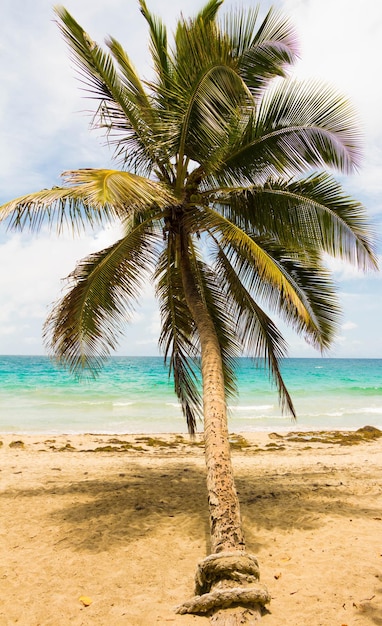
179, 233, 269, 626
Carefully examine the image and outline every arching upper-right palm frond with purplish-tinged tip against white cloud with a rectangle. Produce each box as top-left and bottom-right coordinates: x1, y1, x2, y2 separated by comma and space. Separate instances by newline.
222, 80, 361, 182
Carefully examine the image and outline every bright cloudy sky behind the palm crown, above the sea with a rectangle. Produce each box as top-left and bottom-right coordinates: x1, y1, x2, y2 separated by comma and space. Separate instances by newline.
0, 0, 382, 358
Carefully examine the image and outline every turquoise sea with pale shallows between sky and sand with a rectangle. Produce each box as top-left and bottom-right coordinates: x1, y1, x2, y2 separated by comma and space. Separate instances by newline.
0, 356, 382, 434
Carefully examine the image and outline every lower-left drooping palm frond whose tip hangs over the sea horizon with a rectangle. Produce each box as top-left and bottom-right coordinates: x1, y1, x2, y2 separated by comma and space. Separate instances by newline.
44, 224, 158, 376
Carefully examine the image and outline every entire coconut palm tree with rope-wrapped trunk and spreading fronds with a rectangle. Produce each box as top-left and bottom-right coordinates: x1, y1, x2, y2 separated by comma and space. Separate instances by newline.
1, 0, 376, 624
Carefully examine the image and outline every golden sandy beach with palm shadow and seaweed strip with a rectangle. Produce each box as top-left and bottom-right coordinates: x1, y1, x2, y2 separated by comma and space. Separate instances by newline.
0, 433, 382, 626
